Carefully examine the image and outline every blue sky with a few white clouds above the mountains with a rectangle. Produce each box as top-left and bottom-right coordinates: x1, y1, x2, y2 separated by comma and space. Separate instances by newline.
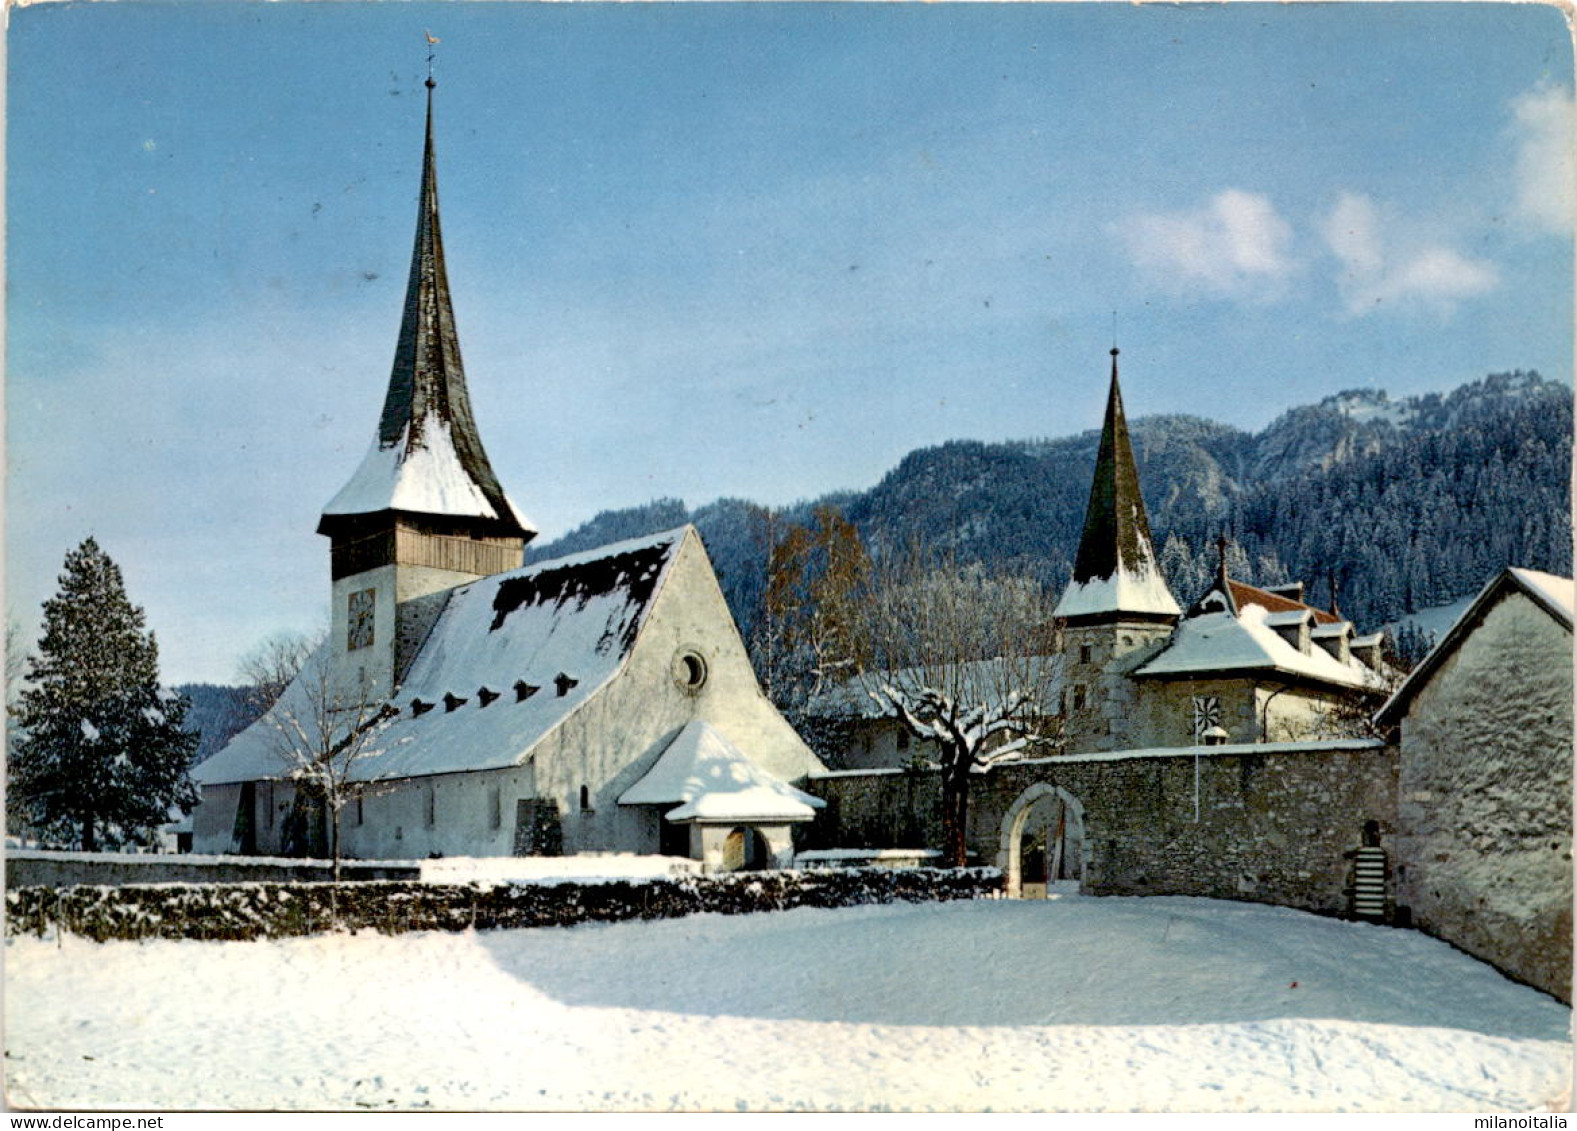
6, 0, 1572, 681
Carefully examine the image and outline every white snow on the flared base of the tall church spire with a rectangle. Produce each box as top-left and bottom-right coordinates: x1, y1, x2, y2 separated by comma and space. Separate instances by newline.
323, 413, 535, 530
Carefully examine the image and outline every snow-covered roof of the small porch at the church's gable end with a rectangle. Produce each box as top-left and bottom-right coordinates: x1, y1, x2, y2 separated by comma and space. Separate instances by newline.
618, 721, 826, 822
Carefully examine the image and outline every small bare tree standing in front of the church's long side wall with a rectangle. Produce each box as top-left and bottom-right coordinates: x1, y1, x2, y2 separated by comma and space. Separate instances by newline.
263, 650, 399, 882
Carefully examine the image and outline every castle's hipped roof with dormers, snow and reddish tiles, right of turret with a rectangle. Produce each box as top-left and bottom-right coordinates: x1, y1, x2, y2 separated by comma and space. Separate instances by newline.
1134, 585, 1381, 689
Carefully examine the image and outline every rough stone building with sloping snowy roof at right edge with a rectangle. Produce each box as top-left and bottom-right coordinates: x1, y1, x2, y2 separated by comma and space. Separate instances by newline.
1380, 569, 1574, 1002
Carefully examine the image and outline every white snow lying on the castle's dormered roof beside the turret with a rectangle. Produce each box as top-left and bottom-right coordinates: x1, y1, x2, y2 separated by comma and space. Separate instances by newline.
1134, 604, 1380, 688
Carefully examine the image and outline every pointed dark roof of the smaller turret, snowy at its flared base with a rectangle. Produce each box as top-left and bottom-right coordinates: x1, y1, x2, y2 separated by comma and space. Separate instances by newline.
1057, 345, 1180, 623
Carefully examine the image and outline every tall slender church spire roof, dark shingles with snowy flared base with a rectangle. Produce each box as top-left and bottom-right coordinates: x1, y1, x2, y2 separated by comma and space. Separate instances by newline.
319, 77, 536, 539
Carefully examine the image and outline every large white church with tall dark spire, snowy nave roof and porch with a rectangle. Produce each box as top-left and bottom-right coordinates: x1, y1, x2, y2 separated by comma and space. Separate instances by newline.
192, 77, 825, 869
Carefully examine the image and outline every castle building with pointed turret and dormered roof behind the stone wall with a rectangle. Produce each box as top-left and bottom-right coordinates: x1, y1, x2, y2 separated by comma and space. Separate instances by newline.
811, 349, 1388, 770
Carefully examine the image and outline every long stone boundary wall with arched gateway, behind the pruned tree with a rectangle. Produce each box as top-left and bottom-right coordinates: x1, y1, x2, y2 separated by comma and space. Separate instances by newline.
806, 740, 1397, 913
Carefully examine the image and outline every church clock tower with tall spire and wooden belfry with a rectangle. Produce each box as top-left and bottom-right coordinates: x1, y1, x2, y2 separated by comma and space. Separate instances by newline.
317, 76, 536, 699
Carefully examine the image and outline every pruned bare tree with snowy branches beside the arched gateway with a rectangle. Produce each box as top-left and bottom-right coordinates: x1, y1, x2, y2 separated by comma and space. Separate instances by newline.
859, 554, 1061, 868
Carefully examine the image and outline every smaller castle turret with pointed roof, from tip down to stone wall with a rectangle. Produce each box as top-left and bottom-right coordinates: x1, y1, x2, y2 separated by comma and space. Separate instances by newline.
1057, 347, 1181, 752
